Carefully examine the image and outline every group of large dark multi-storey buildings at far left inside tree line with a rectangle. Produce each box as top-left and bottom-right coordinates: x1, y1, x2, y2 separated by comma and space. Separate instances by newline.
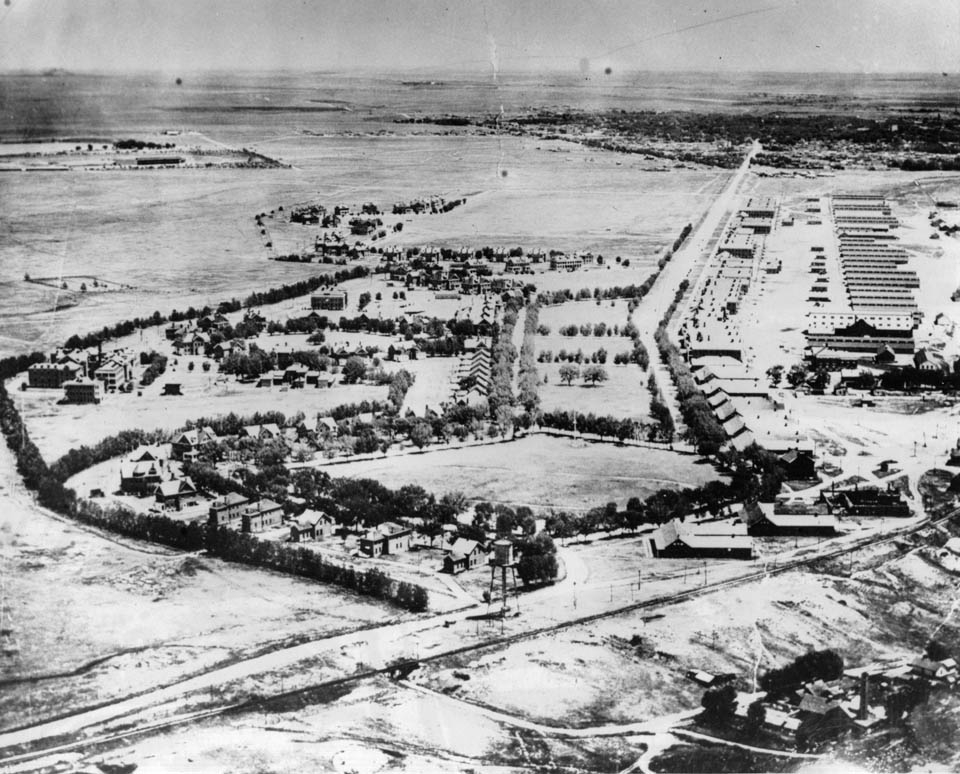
27, 346, 137, 403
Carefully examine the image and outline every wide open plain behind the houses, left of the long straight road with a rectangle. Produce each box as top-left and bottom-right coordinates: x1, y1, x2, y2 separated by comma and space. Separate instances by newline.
0, 118, 725, 360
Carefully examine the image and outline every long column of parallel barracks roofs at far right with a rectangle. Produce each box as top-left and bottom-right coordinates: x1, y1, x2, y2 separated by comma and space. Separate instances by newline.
804, 193, 922, 369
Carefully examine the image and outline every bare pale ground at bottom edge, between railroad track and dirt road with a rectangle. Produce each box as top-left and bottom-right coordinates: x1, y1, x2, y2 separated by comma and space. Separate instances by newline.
41, 679, 643, 774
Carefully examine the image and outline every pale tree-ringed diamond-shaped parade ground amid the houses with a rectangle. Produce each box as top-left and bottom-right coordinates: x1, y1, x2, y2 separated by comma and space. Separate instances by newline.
329, 434, 718, 509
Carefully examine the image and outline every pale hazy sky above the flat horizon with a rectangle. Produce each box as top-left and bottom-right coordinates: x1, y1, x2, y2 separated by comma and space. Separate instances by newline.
0, 0, 960, 75
